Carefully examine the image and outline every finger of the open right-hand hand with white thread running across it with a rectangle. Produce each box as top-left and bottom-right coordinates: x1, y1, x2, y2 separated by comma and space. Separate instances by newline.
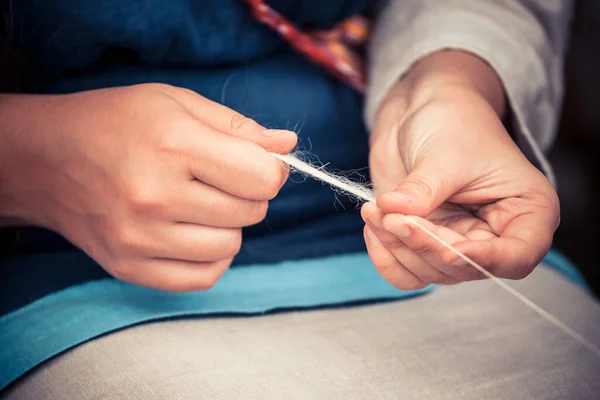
383, 214, 484, 284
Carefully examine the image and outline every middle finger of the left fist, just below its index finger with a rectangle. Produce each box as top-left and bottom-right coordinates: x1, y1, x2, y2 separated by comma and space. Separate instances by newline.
166, 181, 269, 228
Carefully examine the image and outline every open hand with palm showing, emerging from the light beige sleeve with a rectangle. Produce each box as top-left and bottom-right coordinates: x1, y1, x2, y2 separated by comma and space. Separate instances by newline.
362, 52, 559, 290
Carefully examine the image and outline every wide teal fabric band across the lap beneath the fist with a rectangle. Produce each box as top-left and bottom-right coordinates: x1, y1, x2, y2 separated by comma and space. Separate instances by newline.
0, 253, 432, 390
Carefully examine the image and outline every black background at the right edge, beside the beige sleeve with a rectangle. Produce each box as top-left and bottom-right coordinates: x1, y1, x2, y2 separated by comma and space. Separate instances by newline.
550, 0, 600, 297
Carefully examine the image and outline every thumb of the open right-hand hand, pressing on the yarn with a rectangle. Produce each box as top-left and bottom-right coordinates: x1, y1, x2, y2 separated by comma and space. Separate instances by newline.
377, 159, 460, 217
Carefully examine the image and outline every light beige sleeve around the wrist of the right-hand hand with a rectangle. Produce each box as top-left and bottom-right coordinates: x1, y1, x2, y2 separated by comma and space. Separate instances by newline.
365, 0, 572, 182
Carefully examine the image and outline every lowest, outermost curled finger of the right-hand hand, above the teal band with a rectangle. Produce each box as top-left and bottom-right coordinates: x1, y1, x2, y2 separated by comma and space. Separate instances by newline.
364, 226, 427, 291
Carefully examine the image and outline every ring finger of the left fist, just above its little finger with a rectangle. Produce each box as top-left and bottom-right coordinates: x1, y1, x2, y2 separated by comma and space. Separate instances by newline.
155, 223, 242, 262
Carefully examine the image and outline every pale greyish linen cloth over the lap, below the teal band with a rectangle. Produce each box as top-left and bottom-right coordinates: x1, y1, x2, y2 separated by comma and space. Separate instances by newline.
2, 267, 600, 400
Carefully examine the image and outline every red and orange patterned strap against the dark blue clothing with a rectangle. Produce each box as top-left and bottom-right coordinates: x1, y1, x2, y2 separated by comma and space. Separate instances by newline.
244, 0, 370, 93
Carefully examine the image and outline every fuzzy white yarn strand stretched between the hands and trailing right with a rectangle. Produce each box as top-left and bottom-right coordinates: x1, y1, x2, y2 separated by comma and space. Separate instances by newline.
271, 153, 600, 357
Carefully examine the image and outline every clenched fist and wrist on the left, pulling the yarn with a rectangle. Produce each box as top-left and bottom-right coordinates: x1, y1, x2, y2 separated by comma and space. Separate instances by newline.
0, 84, 297, 292
